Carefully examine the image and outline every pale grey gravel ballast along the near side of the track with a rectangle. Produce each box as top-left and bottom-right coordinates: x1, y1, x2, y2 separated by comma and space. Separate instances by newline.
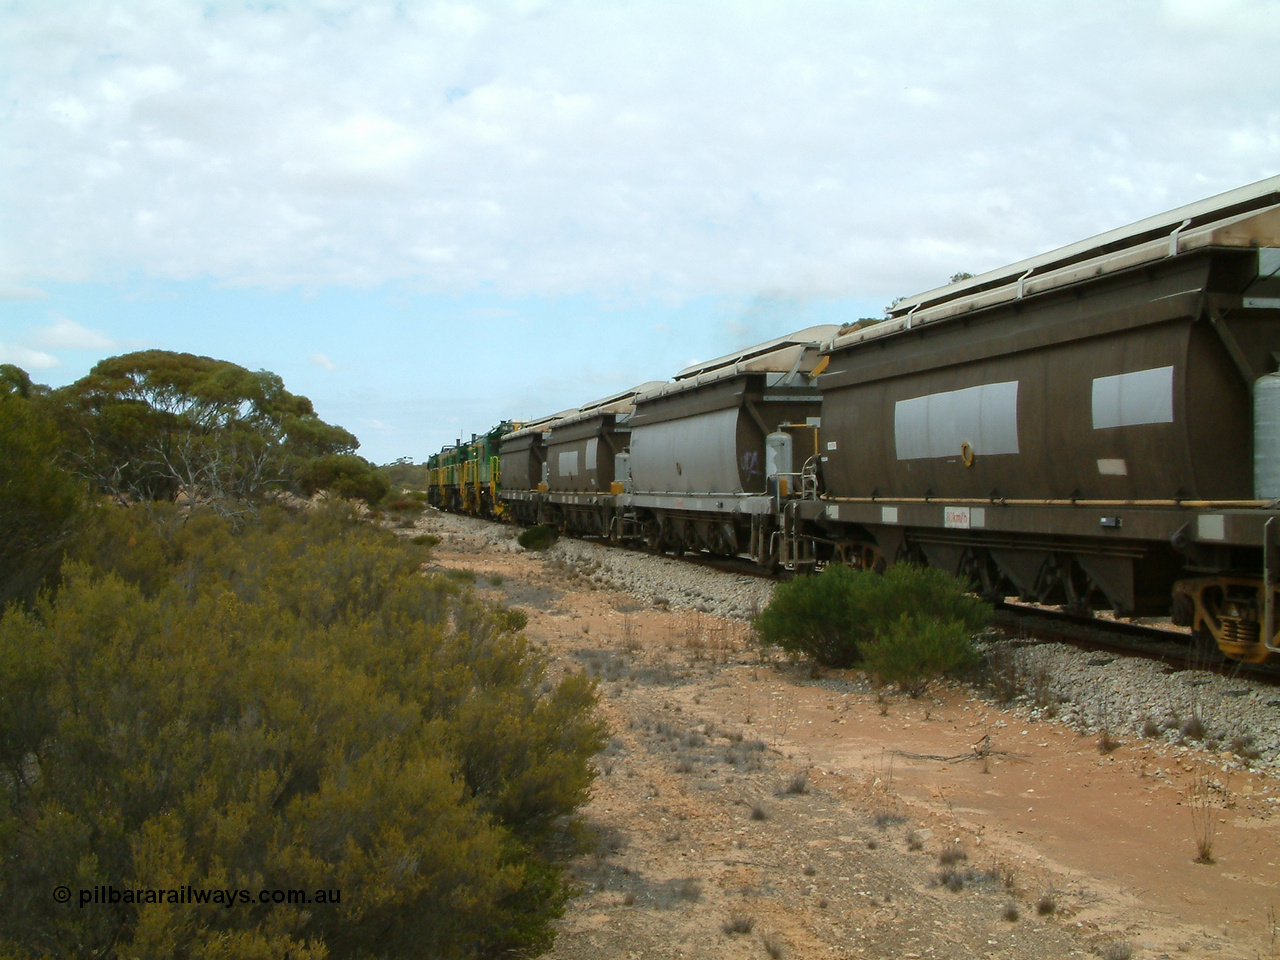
410, 511, 1280, 771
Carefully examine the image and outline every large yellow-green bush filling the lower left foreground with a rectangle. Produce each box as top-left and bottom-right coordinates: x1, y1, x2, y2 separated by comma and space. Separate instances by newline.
0, 504, 604, 960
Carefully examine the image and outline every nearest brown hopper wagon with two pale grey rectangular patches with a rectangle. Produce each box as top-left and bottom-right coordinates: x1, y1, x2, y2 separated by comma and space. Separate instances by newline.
804, 178, 1280, 660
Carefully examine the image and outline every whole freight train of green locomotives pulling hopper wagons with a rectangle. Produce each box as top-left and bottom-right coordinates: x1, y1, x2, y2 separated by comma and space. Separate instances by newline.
429, 177, 1280, 662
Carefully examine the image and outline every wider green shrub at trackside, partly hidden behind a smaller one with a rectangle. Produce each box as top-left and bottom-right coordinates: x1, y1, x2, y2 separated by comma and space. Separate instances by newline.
755, 563, 991, 668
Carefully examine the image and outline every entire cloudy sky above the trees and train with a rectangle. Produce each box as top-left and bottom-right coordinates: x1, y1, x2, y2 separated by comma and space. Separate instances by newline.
0, 0, 1280, 463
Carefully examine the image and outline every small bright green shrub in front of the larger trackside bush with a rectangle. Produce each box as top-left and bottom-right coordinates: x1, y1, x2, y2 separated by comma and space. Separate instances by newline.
859, 613, 978, 698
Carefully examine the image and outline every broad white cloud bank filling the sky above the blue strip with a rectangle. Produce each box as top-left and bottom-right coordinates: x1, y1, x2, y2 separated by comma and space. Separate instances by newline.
0, 0, 1280, 298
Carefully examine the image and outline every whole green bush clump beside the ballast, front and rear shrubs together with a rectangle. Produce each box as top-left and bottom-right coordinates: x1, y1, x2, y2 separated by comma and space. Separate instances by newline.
755, 563, 991, 682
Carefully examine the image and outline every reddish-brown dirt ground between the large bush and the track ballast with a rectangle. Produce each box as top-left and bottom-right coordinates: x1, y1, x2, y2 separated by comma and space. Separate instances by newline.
420, 518, 1280, 960
